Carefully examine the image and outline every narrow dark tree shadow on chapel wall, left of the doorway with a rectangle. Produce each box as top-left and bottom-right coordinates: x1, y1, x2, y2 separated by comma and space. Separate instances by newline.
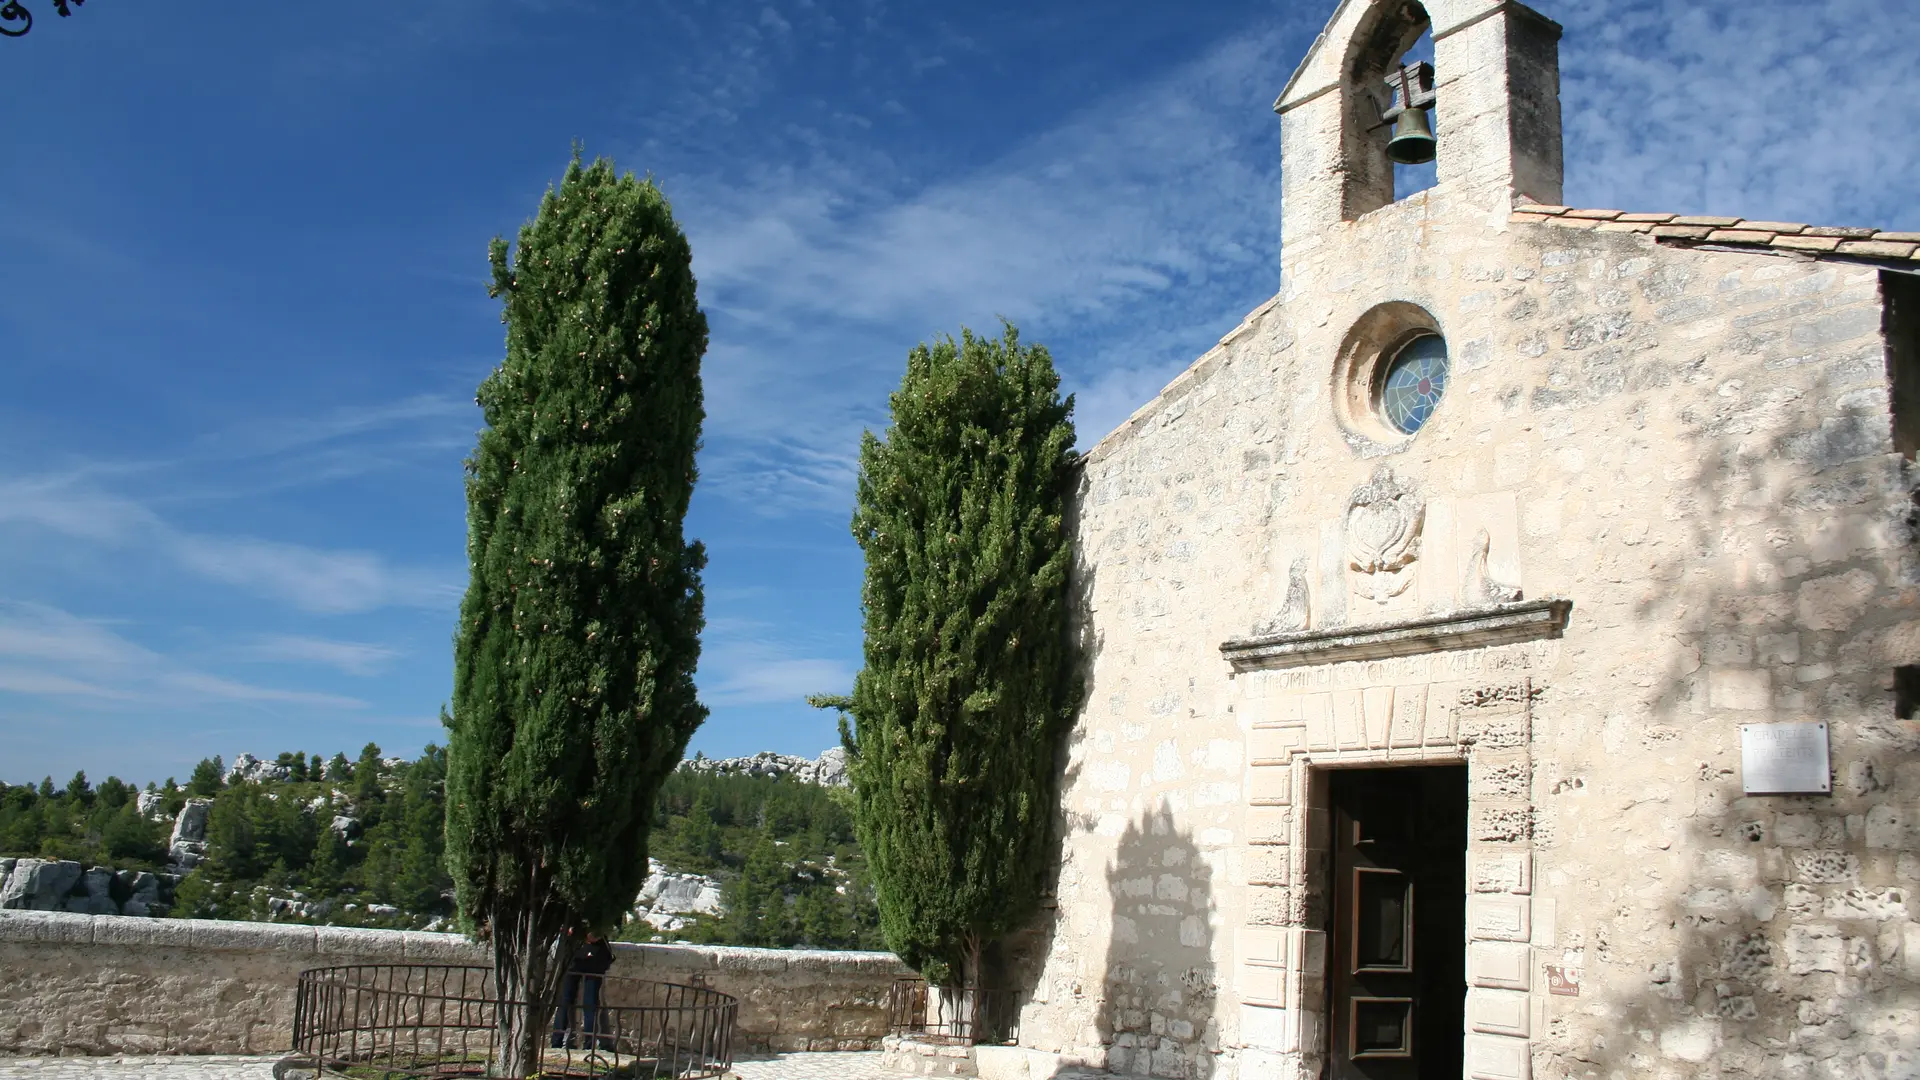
1098, 805, 1219, 1080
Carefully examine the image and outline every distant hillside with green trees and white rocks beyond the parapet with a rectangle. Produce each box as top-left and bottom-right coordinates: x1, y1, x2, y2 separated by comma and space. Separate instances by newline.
0, 744, 877, 947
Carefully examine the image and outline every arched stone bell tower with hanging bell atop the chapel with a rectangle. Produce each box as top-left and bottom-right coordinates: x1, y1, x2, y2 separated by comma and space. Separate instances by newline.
1273, 0, 1561, 261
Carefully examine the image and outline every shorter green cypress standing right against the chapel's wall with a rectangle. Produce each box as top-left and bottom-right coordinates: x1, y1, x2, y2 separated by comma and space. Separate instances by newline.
840, 327, 1079, 986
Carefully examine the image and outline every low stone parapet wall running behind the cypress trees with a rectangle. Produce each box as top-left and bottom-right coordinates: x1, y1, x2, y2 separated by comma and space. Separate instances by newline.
0, 911, 910, 1055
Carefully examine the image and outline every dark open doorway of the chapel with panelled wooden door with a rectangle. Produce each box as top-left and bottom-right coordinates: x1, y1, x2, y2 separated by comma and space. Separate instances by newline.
1327, 765, 1467, 1080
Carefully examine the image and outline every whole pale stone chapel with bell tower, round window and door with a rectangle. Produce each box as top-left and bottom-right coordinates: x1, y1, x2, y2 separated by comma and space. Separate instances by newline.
1006, 0, 1920, 1080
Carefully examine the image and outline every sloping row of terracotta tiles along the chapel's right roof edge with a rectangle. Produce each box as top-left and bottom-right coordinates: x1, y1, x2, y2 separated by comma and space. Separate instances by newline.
1509, 202, 1920, 261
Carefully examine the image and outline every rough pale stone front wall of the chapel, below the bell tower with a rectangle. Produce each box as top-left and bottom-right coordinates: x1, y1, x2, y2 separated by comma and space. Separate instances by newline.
1023, 170, 1920, 1078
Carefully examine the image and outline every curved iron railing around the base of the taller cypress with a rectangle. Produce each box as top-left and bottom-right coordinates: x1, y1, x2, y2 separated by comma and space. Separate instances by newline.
289, 965, 739, 1080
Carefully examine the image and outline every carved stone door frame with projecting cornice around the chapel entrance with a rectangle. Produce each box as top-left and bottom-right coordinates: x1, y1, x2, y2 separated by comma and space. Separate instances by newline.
1221, 600, 1571, 1080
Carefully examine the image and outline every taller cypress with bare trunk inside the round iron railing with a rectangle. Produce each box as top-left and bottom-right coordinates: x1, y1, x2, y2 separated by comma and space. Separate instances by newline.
447, 150, 707, 1076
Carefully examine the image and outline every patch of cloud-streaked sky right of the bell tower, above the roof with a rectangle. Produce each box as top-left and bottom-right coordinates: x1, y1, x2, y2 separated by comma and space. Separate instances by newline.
1559, 0, 1920, 229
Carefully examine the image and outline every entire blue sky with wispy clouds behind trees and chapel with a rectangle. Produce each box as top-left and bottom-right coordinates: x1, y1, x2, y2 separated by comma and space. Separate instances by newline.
0, 0, 1920, 782
